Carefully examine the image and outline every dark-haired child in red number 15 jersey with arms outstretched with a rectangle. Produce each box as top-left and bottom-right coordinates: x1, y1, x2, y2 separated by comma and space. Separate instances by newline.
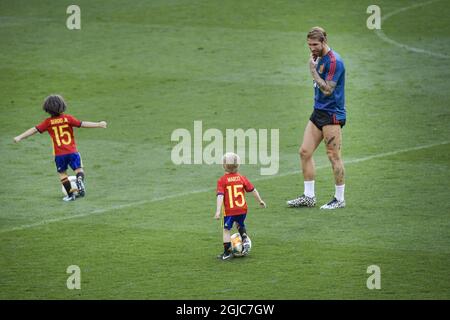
14, 95, 106, 201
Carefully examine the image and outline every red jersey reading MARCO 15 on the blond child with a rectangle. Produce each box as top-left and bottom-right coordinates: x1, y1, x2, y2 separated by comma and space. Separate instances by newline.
217, 173, 255, 216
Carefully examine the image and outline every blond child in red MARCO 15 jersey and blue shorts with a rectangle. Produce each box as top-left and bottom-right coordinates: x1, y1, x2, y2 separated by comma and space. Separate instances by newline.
214, 152, 266, 260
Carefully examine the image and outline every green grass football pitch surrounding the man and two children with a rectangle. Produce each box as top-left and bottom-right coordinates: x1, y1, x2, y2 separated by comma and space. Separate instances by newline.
0, 0, 450, 299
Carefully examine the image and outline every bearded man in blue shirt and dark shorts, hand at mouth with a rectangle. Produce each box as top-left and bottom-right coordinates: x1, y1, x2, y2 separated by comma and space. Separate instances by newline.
287, 27, 346, 209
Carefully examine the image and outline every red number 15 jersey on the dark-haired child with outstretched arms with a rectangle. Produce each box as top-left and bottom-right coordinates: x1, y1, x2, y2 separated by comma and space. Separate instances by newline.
35, 114, 81, 156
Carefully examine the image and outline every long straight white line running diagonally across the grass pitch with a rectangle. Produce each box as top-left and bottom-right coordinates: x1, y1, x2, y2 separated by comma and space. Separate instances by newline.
0, 141, 450, 234
